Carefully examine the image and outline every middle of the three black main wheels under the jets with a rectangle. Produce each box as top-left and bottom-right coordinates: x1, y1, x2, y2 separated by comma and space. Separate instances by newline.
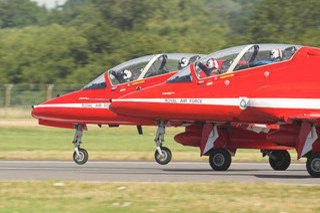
269, 150, 291, 171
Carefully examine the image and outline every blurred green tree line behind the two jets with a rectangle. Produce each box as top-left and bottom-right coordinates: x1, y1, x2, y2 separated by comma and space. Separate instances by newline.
0, 0, 320, 84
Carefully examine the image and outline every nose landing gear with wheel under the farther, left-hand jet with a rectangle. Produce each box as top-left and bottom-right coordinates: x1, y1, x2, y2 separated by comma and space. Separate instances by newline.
72, 124, 88, 165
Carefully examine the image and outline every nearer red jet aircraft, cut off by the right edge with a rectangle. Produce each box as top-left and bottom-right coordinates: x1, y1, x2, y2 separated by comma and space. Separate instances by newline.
110, 44, 320, 177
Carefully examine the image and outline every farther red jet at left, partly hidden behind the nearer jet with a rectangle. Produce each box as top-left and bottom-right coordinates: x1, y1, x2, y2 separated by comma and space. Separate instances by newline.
32, 53, 201, 164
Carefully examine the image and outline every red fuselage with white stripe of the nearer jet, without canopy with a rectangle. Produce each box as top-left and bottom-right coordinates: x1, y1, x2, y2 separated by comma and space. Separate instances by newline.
110, 47, 320, 124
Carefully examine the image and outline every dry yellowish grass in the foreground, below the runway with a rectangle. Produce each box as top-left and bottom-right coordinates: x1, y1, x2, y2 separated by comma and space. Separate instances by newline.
0, 181, 320, 213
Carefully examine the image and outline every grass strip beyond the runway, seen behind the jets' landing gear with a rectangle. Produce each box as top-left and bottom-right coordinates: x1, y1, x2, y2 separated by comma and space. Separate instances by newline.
0, 126, 303, 162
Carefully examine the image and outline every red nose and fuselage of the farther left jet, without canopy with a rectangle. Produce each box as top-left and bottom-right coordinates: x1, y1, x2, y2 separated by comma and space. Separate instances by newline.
32, 72, 174, 128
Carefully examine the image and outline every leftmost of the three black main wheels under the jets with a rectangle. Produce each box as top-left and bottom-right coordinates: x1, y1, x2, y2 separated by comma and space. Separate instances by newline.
209, 149, 231, 171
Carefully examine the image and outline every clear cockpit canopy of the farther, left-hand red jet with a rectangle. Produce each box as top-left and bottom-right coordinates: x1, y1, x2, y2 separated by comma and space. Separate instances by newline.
83, 53, 203, 90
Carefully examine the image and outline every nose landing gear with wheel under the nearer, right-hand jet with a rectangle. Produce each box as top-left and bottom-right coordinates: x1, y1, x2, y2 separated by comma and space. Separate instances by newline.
154, 120, 172, 165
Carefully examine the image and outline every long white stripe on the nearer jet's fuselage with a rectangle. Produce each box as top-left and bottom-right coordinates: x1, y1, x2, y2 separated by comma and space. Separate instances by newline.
112, 98, 320, 109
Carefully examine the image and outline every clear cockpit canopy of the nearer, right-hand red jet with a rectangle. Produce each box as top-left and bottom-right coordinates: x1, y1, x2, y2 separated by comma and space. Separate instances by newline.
167, 44, 301, 83
